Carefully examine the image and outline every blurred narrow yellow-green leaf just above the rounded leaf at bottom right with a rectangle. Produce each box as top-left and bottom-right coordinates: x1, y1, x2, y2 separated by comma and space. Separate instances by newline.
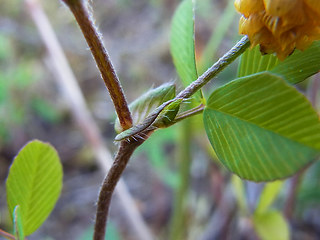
256, 181, 283, 213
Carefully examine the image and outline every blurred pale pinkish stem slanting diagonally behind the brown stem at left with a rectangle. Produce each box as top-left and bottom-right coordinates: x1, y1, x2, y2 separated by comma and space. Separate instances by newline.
25, 0, 153, 240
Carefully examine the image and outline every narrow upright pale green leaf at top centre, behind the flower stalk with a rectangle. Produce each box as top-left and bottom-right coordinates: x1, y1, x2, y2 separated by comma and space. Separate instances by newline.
170, 0, 201, 98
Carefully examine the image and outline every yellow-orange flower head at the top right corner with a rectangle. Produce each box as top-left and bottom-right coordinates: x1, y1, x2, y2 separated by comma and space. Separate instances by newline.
235, 0, 320, 60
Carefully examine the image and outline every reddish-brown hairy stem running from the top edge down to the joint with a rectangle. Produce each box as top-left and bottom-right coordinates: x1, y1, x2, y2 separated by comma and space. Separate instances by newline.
62, 0, 132, 130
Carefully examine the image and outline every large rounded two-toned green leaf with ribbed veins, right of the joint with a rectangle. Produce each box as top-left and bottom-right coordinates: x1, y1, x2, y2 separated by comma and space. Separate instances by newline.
204, 73, 320, 181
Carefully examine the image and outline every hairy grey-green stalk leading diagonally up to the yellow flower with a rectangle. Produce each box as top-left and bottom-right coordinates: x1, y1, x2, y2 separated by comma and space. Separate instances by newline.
176, 36, 250, 99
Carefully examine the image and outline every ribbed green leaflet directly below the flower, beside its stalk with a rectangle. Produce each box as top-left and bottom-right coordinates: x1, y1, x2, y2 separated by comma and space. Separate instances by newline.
238, 46, 279, 77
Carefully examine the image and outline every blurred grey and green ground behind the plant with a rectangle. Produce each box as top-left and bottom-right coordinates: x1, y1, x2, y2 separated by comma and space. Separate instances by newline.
0, 0, 320, 240
